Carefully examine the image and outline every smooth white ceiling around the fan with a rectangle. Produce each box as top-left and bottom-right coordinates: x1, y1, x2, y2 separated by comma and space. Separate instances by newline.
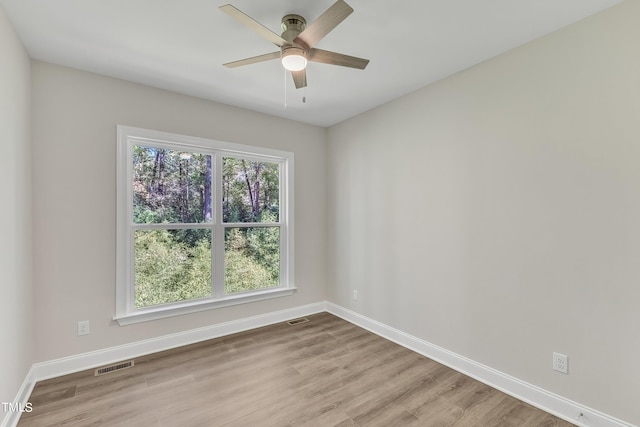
0, 0, 620, 126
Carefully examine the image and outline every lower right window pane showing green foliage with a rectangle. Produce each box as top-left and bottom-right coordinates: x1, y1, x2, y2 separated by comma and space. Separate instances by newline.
224, 227, 280, 294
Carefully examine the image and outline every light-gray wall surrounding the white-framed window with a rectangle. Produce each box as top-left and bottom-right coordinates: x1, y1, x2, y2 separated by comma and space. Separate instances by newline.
32, 61, 326, 361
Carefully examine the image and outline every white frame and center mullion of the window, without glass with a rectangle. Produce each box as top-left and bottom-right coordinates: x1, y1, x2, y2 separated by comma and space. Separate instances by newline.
113, 125, 296, 325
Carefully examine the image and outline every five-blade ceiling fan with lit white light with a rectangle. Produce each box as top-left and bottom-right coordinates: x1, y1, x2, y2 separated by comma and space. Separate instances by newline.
220, 0, 369, 89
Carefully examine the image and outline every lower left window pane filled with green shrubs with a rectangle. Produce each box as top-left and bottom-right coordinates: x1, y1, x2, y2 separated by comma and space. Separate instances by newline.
135, 229, 211, 308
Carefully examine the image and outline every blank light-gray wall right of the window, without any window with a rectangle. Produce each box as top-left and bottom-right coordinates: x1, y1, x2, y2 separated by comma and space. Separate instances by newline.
328, 1, 640, 424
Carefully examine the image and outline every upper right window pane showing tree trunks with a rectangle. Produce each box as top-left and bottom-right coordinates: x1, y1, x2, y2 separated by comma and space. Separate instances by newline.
222, 157, 280, 222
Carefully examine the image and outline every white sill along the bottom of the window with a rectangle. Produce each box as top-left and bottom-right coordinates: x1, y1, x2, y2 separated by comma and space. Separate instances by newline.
113, 288, 296, 326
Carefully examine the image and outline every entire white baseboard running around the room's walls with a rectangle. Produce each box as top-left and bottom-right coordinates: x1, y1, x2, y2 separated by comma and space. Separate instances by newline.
0, 301, 634, 427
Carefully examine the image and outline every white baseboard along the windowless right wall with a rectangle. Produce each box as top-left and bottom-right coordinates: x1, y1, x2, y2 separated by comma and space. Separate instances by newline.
327, 302, 634, 427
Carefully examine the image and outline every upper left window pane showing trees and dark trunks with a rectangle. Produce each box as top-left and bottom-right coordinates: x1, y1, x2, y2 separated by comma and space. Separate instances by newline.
132, 146, 211, 224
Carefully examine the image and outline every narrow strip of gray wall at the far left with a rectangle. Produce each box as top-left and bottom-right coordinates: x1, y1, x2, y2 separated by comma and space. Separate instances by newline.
0, 7, 33, 408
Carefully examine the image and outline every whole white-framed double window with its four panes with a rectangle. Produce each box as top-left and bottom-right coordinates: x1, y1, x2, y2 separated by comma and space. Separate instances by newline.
114, 126, 294, 325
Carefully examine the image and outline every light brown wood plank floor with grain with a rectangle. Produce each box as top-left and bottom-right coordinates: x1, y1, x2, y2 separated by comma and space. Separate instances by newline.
19, 313, 572, 427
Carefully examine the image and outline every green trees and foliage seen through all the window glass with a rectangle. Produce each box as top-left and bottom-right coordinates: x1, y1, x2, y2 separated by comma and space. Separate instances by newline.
132, 146, 280, 307
